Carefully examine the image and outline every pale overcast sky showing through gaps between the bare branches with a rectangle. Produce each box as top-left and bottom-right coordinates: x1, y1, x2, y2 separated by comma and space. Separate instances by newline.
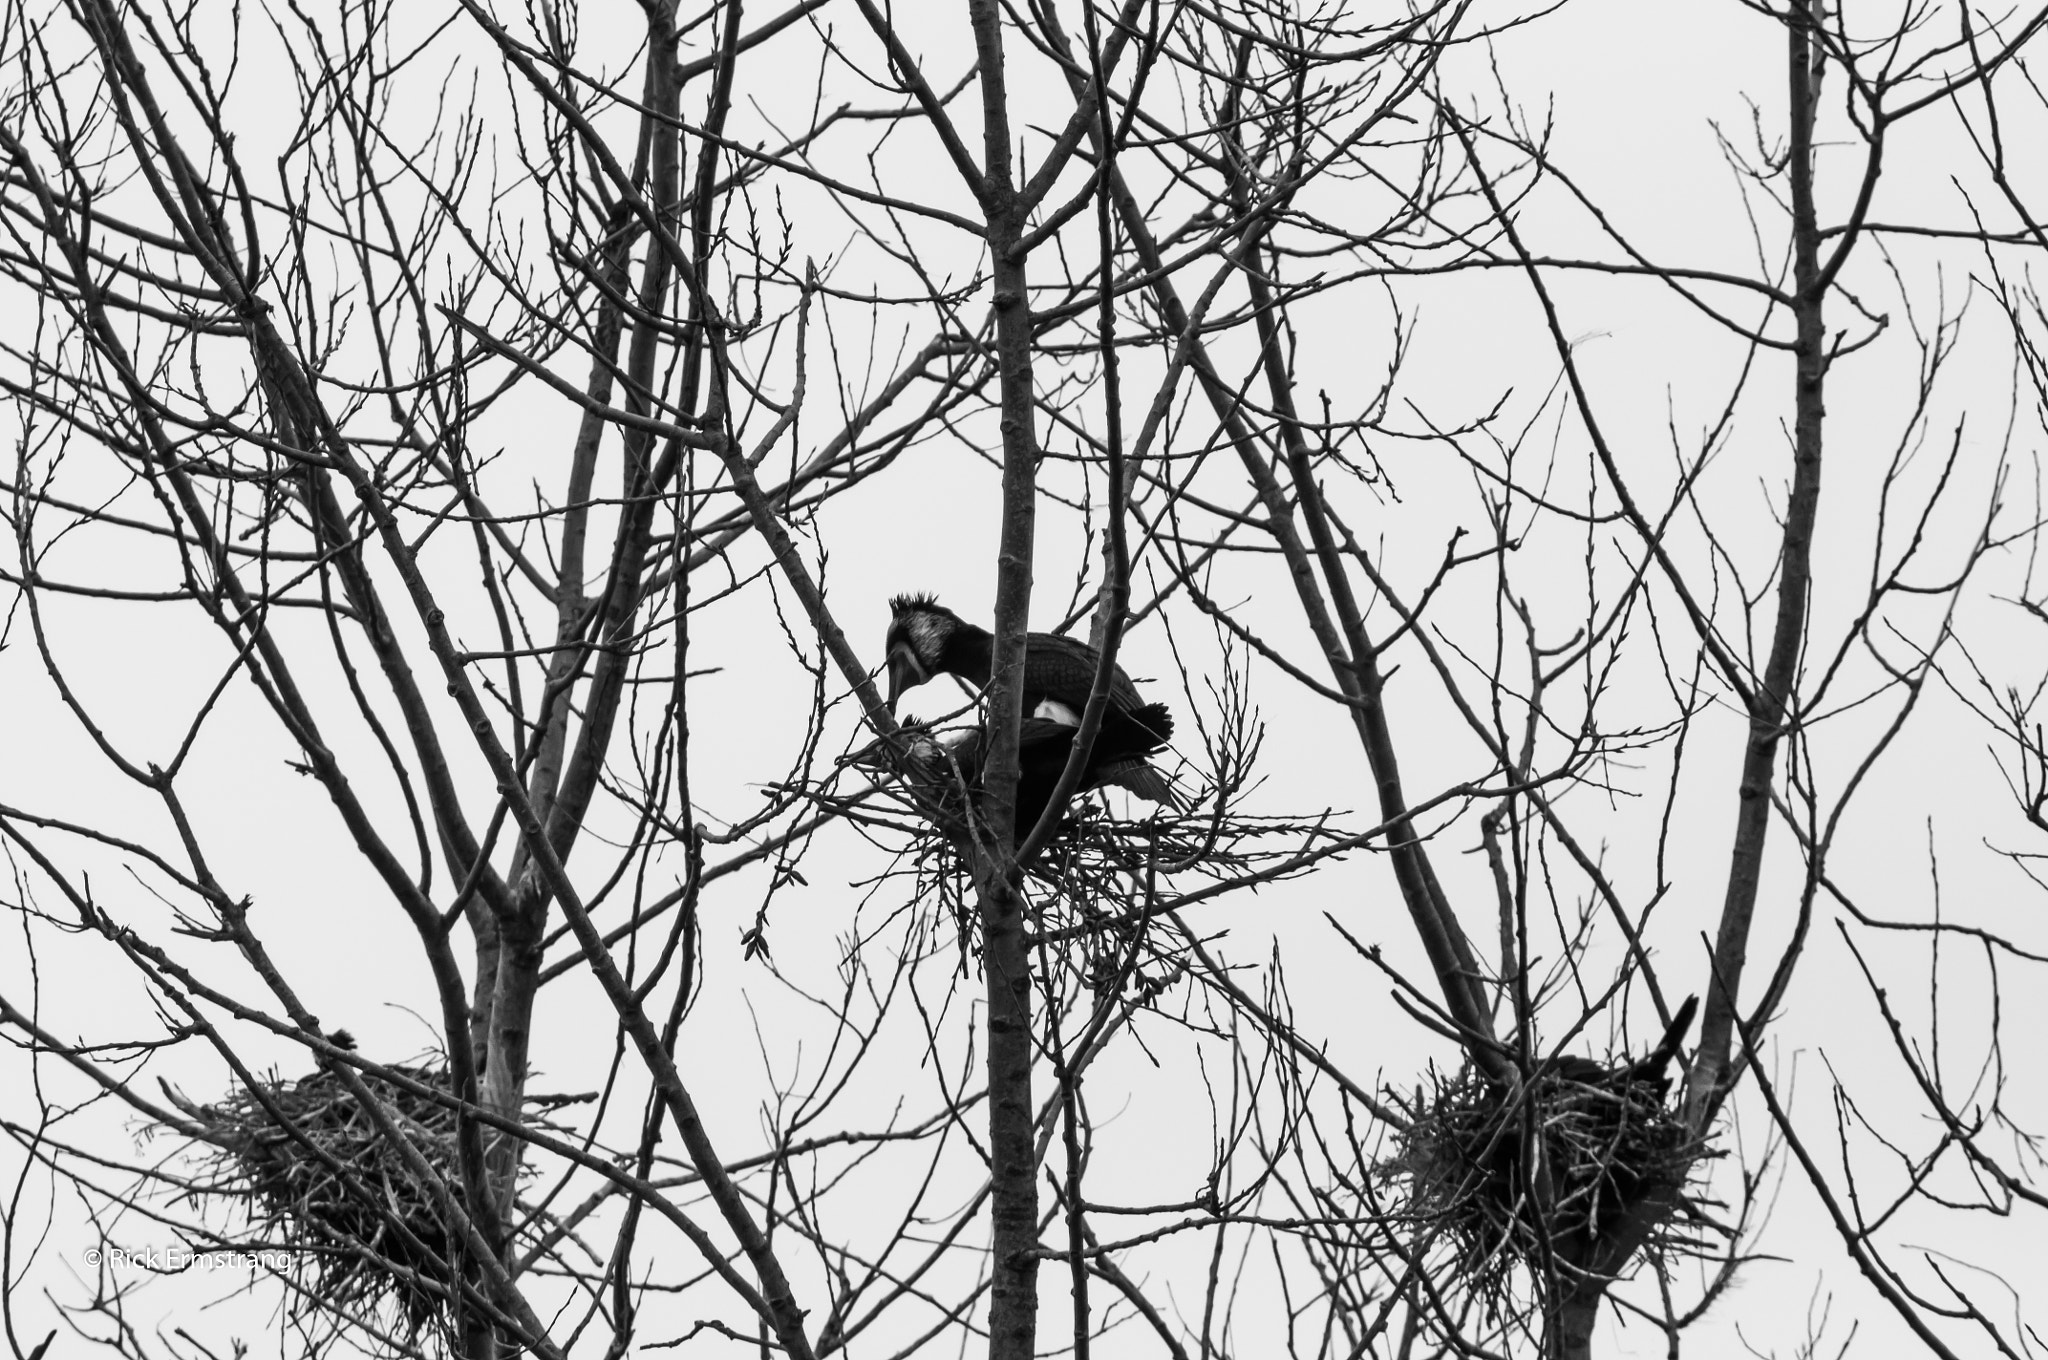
0, 0, 2048, 1356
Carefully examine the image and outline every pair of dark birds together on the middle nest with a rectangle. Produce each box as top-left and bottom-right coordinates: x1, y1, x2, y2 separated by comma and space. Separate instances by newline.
887, 594, 1176, 838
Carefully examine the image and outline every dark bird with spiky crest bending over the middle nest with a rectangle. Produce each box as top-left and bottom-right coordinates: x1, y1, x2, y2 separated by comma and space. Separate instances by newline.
887, 596, 1176, 802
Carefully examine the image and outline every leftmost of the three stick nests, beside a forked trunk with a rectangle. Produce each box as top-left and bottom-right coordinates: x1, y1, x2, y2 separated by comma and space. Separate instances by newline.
169, 1061, 520, 1337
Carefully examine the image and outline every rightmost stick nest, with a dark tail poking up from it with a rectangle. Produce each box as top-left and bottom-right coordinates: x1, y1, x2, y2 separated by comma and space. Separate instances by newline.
1384, 1057, 1704, 1303
